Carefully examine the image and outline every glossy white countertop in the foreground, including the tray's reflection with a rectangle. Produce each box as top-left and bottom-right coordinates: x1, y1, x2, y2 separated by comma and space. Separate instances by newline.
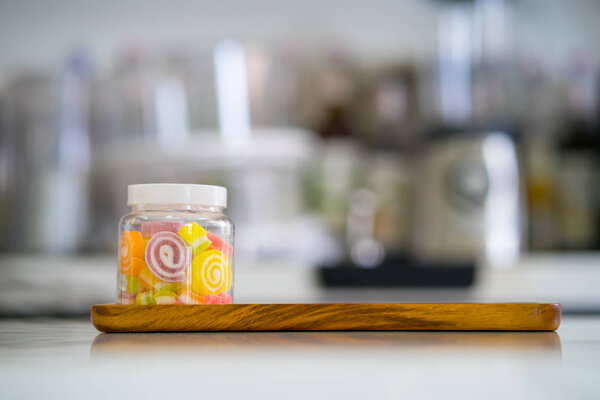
0, 317, 600, 400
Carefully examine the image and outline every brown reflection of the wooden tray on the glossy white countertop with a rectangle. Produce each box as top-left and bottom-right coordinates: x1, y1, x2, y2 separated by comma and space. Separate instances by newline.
91, 332, 561, 359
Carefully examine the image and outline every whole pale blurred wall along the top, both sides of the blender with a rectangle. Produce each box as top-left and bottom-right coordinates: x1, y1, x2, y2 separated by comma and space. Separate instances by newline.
0, 0, 600, 71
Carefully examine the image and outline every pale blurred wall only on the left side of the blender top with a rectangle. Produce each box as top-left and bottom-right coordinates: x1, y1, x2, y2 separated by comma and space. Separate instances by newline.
0, 0, 437, 69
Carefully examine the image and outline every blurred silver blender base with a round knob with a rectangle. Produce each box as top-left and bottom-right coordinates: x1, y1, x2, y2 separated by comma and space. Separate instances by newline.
413, 132, 522, 267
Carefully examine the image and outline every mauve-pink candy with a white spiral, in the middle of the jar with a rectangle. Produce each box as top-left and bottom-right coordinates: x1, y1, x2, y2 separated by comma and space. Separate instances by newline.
146, 232, 189, 282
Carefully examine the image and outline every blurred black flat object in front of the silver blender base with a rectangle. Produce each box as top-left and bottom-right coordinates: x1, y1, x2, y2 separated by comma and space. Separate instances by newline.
318, 259, 475, 287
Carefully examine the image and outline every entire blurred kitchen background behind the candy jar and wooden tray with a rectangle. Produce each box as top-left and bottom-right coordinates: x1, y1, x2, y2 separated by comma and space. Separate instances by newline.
0, 0, 600, 316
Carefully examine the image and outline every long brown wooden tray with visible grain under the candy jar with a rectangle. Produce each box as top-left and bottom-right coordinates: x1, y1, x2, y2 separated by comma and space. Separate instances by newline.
91, 303, 561, 332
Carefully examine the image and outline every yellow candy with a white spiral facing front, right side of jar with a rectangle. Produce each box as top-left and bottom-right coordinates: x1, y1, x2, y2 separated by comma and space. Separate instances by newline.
191, 250, 231, 295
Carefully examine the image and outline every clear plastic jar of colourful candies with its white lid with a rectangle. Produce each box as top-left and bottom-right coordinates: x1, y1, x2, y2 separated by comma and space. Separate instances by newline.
117, 184, 234, 305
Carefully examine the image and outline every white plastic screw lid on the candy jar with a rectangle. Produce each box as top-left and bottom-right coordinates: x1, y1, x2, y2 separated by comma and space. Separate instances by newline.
127, 183, 227, 207
